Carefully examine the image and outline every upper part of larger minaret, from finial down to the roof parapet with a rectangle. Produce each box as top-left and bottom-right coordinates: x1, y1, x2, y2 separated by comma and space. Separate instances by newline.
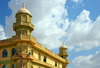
13, 3, 34, 35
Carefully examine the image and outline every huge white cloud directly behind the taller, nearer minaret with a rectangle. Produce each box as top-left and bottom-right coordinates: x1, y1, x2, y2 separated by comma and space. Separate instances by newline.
5, 0, 69, 49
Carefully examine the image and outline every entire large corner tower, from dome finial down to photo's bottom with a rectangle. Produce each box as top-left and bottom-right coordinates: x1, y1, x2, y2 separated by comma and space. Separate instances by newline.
13, 3, 36, 68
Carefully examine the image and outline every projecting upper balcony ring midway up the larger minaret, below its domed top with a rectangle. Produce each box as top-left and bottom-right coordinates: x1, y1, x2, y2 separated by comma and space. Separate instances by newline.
13, 22, 34, 31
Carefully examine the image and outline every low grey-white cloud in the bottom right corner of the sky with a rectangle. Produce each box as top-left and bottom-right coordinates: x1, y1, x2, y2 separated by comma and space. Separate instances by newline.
72, 50, 100, 68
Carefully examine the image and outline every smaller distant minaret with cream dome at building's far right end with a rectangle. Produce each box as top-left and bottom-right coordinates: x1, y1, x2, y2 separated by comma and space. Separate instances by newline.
58, 42, 69, 68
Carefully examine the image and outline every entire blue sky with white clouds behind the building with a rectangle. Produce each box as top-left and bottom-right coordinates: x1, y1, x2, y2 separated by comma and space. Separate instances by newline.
0, 0, 100, 68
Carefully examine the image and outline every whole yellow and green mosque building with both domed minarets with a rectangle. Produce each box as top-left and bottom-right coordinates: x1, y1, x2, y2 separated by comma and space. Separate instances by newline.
0, 3, 70, 68
